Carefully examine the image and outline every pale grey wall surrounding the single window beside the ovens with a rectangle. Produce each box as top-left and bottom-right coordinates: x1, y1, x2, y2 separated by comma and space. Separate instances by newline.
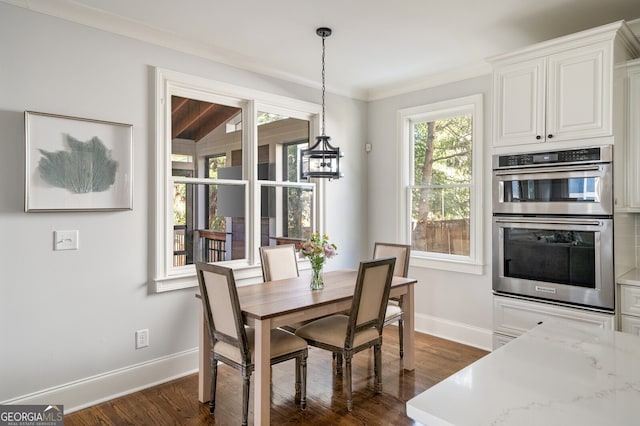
368, 75, 492, 349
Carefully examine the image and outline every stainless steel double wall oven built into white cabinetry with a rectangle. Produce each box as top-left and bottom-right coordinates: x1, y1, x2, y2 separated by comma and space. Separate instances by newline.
493, 146, 615, 311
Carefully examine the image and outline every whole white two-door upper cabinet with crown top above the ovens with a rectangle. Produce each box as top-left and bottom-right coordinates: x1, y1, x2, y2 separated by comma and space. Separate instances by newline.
489, 22, 640, 151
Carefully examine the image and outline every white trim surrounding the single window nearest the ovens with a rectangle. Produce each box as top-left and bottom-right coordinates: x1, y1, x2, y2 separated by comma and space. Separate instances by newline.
398, 94, 484, 275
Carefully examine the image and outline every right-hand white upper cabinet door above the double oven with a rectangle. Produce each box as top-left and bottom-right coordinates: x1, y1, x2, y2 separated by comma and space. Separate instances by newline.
546, 42, 613, 142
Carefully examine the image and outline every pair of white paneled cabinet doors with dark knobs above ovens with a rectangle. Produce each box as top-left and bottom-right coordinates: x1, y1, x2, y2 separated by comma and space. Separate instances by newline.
494, 43, 612, 146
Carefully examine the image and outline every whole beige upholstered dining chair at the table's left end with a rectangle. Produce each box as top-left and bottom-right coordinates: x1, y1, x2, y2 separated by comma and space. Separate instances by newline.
196, 262, 308, 425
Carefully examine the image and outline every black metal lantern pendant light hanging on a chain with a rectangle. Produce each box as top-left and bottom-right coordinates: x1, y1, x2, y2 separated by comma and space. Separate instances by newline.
300, 27, 344, 179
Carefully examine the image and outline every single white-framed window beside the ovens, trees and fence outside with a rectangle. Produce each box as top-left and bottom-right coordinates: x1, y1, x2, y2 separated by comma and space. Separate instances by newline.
399, 95, 482, 273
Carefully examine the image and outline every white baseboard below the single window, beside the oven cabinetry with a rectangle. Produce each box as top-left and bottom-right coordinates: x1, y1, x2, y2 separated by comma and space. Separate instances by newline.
415, 314, 493, 351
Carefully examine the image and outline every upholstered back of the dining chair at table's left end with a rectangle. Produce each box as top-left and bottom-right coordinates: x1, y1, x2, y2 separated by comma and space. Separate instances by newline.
196, 262, 251, 364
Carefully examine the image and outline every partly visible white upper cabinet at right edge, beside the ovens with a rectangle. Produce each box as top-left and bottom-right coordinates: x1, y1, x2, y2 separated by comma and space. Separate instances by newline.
619, 60, 640, 212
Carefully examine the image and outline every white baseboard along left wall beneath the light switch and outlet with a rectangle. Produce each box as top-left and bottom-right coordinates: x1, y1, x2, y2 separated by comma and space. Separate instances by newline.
0, 348, 198, 414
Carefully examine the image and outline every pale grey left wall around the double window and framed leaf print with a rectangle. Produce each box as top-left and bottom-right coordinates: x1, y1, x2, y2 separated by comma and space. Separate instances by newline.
0, 3, 367, 412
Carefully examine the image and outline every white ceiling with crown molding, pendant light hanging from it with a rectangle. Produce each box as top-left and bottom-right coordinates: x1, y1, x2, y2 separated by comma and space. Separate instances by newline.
0, 0, 640, 99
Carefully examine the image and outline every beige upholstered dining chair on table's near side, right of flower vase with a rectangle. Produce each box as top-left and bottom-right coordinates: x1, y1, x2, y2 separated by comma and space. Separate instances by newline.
296, 257, 396, 411
